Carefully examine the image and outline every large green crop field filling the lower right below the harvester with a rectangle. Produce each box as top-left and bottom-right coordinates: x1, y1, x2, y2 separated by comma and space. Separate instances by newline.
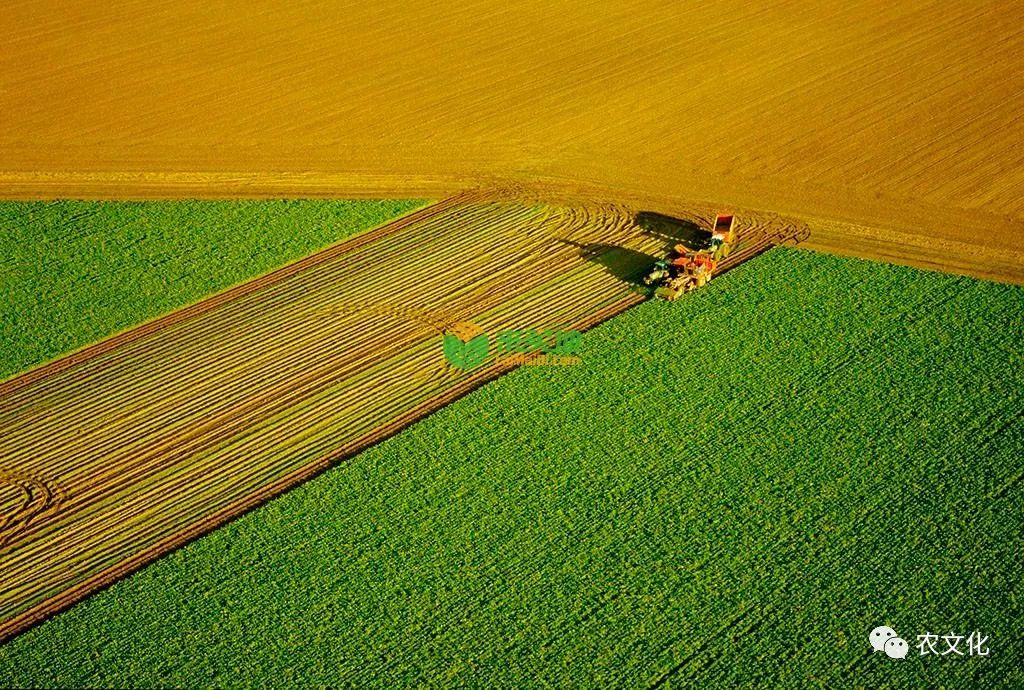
0, 244, 1024, 687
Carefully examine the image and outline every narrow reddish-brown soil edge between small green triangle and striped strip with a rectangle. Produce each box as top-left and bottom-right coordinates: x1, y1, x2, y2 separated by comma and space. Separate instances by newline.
0, 191, 475, 397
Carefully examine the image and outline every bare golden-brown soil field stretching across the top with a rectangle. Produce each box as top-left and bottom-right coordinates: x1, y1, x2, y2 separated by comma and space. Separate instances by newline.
0, 0, 1024, 283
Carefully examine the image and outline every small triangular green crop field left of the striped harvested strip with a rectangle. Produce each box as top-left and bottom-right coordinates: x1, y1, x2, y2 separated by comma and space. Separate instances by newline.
0, 201, 422, 379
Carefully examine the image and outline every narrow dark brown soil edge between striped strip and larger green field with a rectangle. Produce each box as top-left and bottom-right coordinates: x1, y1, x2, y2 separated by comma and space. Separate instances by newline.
0, 288, 647, 644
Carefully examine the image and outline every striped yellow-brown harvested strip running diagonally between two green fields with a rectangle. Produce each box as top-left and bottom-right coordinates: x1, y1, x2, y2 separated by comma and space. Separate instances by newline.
0, 189, 774, 638
